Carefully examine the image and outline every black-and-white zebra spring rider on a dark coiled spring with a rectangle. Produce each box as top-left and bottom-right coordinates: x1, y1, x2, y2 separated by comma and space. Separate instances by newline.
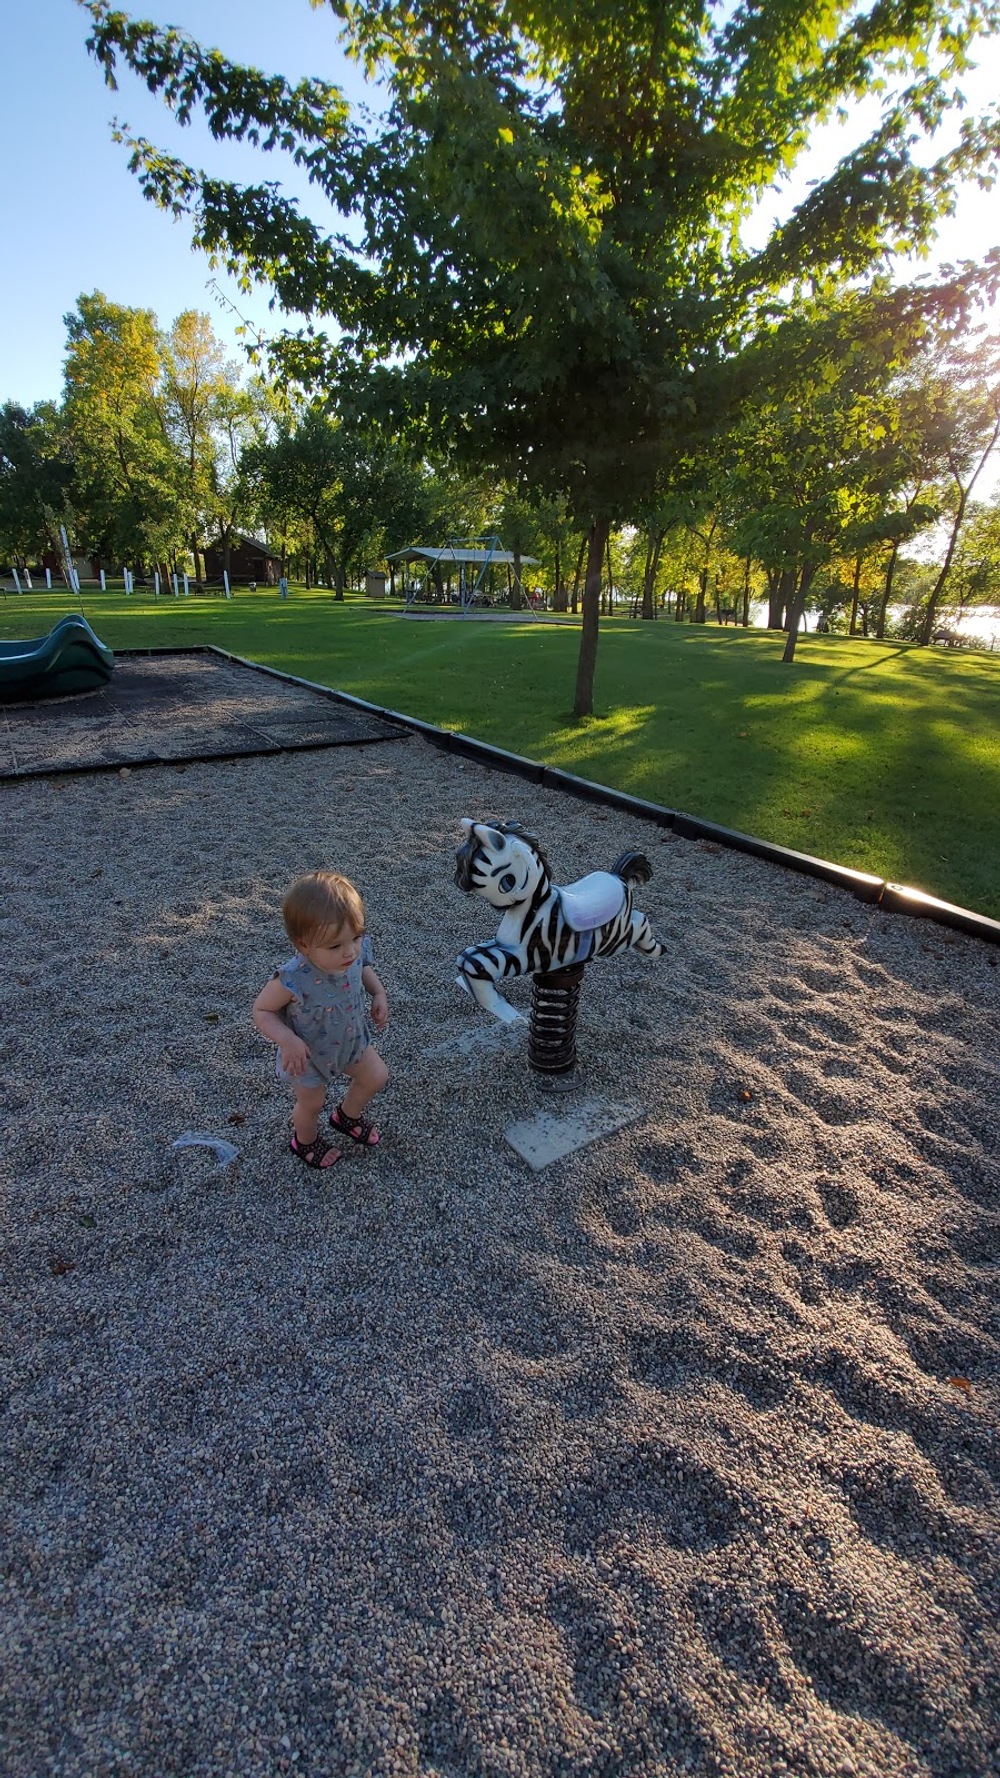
456, 820, 665, 1076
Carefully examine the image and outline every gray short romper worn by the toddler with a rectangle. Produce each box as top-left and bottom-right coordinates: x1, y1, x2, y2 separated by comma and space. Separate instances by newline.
274, 933, 375, 1086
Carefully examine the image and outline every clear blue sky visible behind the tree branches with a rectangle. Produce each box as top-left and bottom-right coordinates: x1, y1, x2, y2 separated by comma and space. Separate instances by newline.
0, 0, 1000, 405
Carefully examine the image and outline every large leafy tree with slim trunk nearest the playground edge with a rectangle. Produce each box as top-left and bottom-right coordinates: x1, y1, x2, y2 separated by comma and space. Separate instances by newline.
89, 0, 1000, 715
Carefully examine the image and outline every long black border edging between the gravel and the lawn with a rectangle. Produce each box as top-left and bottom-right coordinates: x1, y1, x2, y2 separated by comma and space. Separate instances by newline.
119, 642, 1000, 944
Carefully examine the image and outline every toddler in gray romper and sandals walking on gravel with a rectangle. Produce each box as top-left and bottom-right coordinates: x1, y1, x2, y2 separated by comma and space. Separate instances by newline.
253, 871, 390, 1168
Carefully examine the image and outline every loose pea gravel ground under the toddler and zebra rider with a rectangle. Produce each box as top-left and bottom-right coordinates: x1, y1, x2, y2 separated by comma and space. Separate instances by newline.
0, 740, 1000, 1778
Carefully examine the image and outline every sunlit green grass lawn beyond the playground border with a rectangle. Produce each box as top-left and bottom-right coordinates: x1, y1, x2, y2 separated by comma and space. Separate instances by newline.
0, 589, 1000, 917
